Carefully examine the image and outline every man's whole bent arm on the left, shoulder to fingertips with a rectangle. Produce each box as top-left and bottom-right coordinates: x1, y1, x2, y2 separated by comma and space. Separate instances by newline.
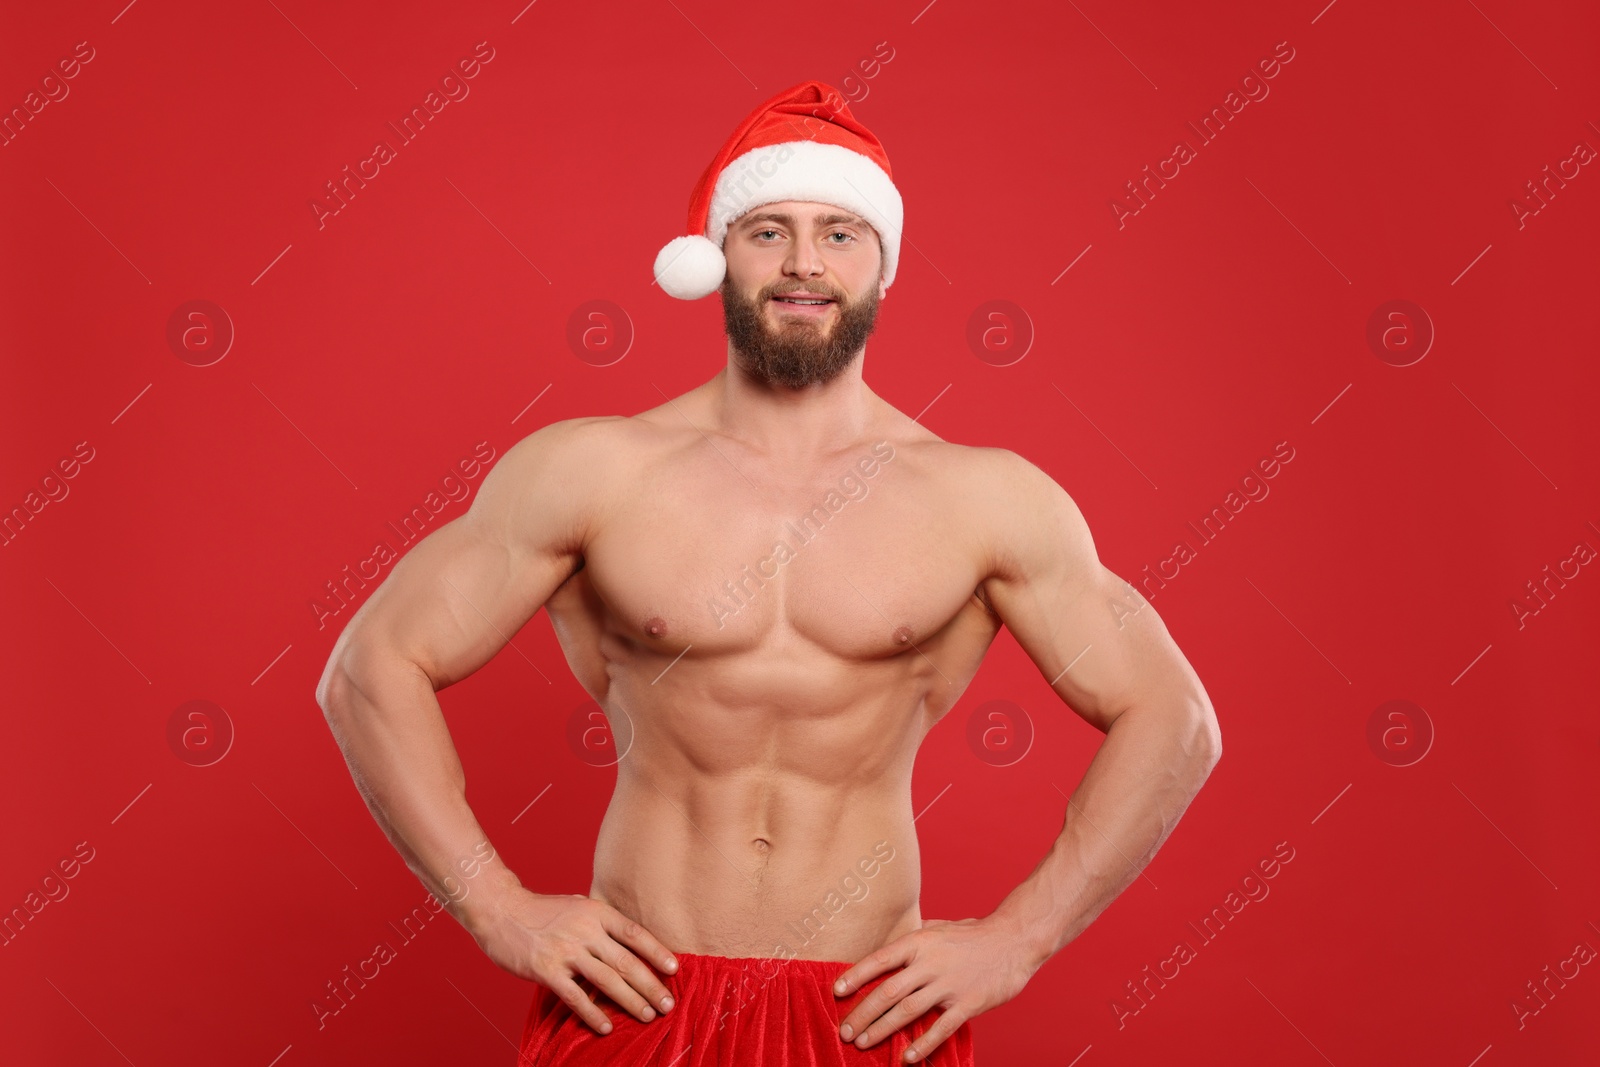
317, 419, 677, 1033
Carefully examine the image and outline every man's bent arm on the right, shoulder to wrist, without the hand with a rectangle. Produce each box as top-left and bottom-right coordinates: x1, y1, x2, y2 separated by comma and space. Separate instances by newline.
984, 451, 1222, 973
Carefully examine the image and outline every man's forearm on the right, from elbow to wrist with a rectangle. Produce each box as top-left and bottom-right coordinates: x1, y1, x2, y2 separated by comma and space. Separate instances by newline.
995, 702, 1221, 971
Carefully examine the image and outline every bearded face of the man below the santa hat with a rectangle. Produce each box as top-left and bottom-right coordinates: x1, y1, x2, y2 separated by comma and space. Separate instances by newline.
722, 200, 883, 389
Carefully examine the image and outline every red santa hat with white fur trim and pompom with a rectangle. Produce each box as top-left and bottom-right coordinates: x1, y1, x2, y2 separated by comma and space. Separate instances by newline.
654, 82, 904, 301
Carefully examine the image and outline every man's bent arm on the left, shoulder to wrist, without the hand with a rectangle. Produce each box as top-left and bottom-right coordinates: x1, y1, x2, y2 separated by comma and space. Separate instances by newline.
317, 419, 590, 931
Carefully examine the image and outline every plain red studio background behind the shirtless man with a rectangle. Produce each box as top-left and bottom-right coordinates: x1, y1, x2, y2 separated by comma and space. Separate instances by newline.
0, 0, 1600, 1067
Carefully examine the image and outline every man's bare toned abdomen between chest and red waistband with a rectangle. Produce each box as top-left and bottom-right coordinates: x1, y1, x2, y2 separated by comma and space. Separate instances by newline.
590, 656, 926, 961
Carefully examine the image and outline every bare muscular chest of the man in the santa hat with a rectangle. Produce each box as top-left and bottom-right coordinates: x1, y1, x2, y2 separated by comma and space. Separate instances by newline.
582, 450, 979, 661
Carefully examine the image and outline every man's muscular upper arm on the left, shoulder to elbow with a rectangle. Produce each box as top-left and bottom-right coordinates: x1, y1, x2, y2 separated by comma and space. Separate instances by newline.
334, 424, 590, 689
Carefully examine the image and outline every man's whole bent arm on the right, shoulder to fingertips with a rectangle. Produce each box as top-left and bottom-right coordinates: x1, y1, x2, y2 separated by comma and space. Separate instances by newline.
834, 450, 1222, 1062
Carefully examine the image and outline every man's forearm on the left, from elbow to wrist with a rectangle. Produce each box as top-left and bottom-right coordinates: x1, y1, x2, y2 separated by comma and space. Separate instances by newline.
318, 643, 522, 934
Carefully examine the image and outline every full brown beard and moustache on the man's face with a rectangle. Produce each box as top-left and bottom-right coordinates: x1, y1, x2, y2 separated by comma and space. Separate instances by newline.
722, 278, 878, 389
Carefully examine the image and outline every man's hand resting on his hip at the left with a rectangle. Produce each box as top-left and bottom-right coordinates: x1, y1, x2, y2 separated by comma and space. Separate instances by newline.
472, 888, 678, 1033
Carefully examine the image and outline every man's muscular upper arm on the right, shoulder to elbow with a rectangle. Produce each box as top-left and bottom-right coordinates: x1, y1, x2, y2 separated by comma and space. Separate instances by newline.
986, 456, 1198, 731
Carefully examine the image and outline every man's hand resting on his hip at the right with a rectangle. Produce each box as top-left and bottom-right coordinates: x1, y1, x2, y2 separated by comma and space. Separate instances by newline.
834, 918, 1034, 1062
